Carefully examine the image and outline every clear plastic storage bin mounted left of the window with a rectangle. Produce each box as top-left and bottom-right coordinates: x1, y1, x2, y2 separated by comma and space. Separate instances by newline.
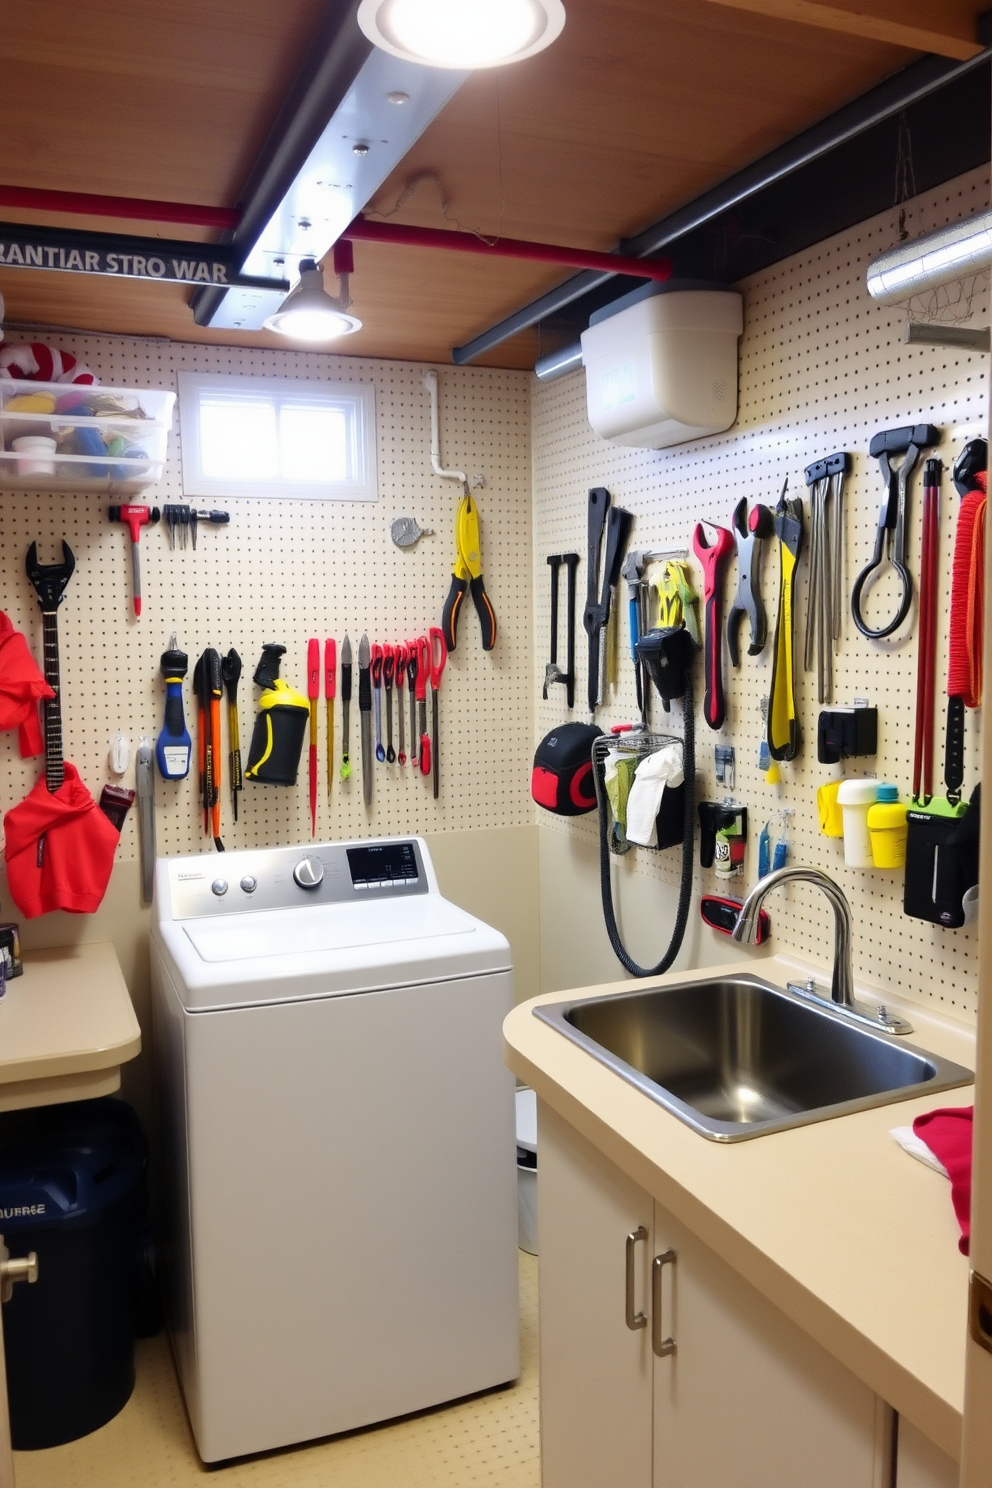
0, 379, 175, 497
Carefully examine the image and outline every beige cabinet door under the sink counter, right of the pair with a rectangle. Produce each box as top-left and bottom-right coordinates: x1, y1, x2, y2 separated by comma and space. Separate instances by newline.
653, 1205, 888, 1488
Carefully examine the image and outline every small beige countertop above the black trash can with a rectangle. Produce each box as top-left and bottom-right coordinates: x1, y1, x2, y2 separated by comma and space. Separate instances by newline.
0, 940, 141, 1112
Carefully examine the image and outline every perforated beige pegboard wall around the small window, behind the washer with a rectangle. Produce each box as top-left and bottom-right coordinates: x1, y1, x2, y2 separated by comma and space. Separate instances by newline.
0, 340, 532, 860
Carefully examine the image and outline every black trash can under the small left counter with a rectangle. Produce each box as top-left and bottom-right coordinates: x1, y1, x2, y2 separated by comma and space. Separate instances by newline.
0, 1098, 147, 1451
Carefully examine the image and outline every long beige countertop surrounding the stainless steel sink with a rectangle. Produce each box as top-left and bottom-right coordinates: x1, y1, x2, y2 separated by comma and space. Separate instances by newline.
504, 954, 974, 1458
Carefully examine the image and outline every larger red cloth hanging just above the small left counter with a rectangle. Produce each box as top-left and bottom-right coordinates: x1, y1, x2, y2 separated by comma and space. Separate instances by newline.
3, 762, 120, 920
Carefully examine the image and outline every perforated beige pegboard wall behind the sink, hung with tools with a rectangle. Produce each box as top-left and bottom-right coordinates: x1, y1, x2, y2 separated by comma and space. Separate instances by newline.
532, 170, 989, 1019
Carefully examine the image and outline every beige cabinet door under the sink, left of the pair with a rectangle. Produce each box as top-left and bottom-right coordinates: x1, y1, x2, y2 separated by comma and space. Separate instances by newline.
537, 1103, 653, 1488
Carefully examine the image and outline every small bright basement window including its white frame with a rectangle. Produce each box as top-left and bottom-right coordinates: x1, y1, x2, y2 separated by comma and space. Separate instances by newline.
178, 372, 378, 501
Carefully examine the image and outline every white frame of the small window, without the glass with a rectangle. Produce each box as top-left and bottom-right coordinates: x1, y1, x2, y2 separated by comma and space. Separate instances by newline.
178, 372, 379, 501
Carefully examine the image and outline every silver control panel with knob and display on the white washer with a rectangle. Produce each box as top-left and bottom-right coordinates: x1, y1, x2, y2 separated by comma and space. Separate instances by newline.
159, 838, 431, 920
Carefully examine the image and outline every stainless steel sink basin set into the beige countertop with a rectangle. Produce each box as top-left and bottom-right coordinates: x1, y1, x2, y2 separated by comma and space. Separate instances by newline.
534, 973, 974, 1141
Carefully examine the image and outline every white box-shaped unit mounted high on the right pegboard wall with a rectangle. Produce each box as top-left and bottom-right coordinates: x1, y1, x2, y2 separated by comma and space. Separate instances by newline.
582, 281, 744, 449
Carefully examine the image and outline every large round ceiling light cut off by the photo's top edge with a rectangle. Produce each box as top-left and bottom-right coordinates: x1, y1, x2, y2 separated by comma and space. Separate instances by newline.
358, 0, 565, 68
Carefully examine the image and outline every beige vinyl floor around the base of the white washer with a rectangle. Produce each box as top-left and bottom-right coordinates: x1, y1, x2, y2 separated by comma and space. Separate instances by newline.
15, 1251, 540, 1488
